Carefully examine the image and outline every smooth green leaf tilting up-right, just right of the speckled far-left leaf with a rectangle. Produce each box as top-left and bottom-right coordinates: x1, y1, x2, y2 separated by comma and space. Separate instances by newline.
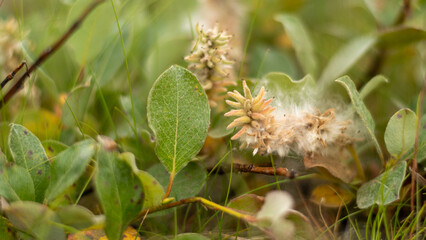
46, 140, 96, 201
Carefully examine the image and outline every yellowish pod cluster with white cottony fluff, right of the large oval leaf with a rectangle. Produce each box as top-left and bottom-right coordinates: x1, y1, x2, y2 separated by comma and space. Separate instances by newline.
225, 81, 359, 156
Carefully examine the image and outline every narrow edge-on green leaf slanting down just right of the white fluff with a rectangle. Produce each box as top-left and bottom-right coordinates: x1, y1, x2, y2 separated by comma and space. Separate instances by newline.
335, 76, 383, 160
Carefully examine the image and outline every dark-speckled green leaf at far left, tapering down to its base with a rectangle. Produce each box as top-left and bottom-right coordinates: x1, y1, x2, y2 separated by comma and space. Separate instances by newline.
9, 124, 50, 202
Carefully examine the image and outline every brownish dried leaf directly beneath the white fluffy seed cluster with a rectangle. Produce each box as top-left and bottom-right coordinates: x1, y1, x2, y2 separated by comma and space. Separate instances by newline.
303, 154, 356, 183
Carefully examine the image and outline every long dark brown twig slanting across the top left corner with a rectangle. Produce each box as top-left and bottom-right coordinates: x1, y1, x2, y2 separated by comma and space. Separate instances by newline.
0, 0, 105, 109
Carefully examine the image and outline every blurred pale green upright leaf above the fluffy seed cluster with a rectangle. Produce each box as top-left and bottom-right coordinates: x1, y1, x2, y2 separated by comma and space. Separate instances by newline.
275, 14, 317, 75
